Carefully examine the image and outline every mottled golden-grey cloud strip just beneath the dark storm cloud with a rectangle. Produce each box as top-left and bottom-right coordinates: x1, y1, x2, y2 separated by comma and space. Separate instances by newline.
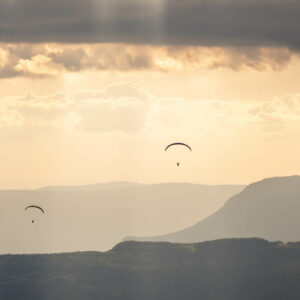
0, 44, 299, 78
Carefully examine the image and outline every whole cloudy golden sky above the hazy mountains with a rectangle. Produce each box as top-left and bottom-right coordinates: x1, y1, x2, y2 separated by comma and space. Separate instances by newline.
0, 0, 300, 189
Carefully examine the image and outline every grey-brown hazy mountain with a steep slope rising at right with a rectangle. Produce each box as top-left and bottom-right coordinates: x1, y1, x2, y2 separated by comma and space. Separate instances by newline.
129, 176, 300, 243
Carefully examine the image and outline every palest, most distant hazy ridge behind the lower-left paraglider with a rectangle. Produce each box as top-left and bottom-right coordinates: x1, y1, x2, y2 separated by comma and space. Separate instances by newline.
0, 183, 242, 253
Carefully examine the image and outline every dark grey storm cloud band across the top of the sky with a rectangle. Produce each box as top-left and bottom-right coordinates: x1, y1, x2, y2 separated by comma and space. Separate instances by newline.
0, 0, 300, 49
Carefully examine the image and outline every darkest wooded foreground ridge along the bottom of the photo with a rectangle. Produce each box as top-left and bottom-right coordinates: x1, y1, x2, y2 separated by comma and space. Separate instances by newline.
0, 239, 300, 300
